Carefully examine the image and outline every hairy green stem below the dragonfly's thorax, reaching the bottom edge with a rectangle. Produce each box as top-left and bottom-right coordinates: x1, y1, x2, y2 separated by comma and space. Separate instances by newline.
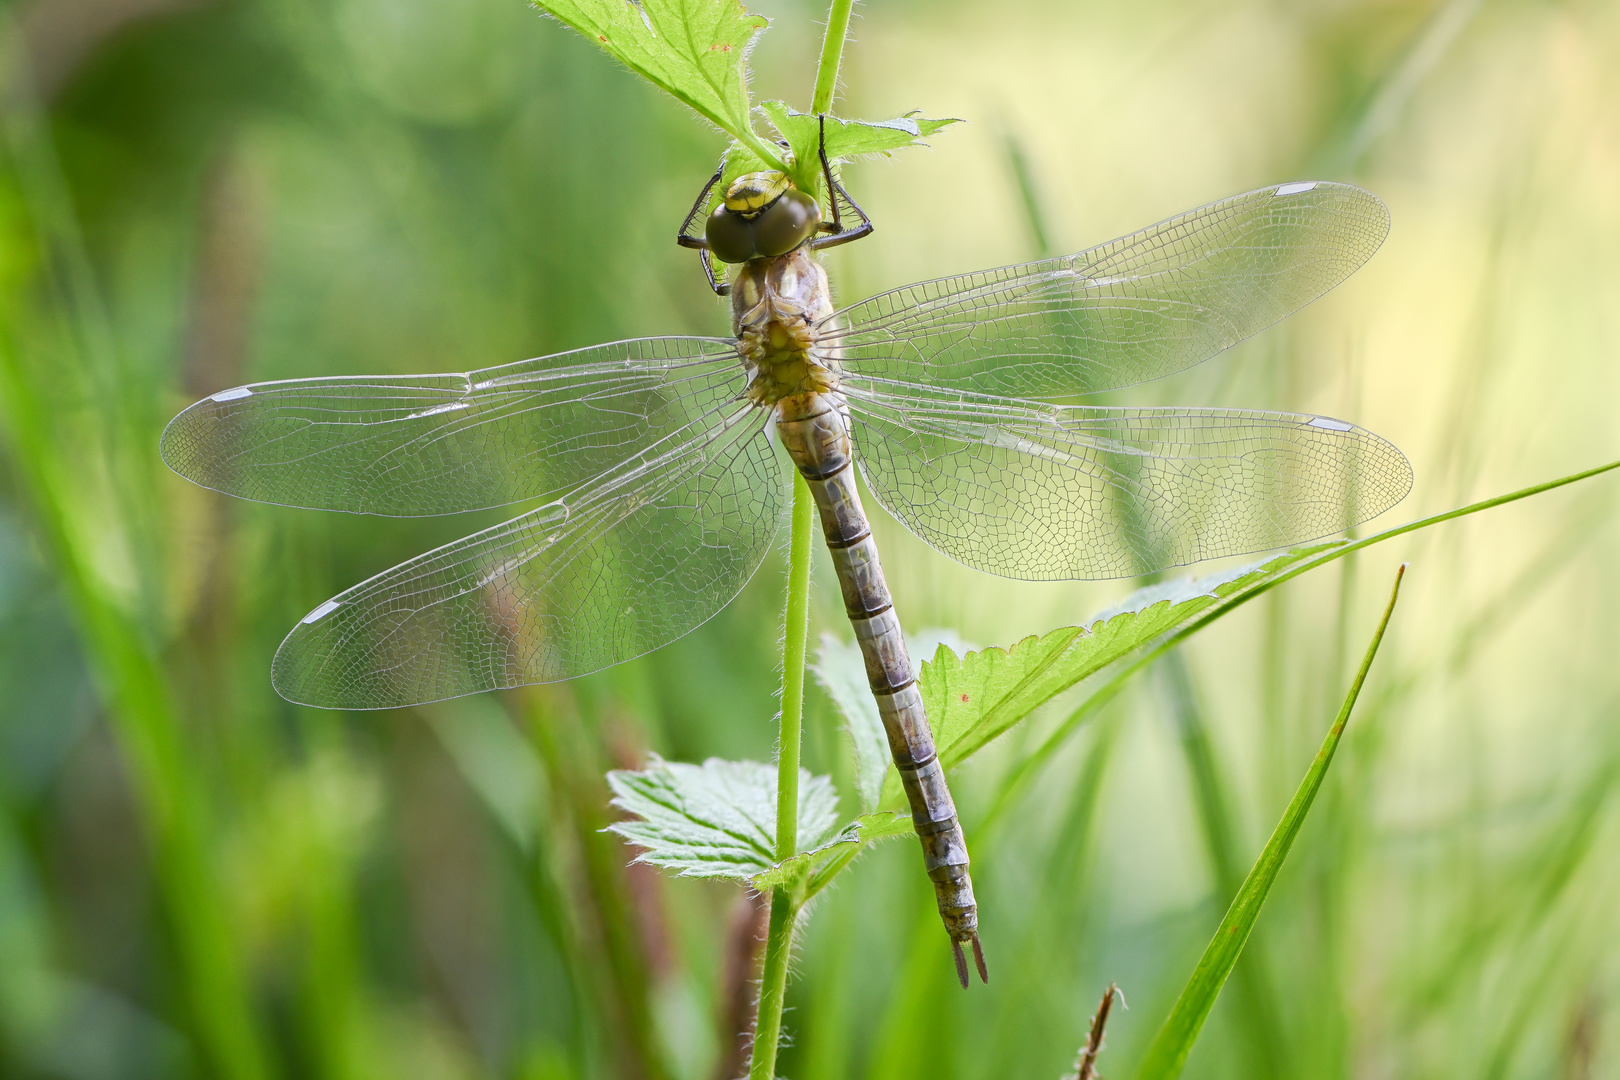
748, 470, 815, 1080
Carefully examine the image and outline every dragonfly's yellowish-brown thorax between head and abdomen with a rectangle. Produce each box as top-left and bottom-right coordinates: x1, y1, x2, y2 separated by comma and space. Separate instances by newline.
731, 248, 838, 406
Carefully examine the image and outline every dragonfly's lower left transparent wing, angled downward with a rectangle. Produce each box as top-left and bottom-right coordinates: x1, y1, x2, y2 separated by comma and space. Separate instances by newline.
271, 405, 784, 709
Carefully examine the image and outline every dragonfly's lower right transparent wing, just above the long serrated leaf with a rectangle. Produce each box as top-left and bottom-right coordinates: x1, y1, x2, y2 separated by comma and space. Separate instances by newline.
846, 385, 1413, 581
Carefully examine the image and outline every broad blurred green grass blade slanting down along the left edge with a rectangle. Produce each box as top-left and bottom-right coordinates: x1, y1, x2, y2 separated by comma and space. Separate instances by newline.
0, 80, 272, 1080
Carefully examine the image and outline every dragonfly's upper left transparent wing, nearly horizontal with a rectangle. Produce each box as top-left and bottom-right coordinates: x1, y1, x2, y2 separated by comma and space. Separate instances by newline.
160, 337, 744, 517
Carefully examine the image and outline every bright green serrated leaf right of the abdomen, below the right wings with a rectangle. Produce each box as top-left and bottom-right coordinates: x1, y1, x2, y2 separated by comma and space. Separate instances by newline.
919, 541, 1346, 769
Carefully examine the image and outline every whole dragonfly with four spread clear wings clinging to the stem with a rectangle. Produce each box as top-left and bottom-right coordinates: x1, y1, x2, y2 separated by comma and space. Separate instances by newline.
160, 132, 1413, 988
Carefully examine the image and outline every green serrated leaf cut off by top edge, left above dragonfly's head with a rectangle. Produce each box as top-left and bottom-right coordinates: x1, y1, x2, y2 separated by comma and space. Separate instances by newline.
535, 0, 784, 168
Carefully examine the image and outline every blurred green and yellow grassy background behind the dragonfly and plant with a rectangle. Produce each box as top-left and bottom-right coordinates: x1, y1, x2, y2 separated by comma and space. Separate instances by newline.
0, 0, 1620, 1080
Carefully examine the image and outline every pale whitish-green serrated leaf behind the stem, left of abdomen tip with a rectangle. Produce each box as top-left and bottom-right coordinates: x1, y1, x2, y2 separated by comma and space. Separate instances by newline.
608, 756, 839, 881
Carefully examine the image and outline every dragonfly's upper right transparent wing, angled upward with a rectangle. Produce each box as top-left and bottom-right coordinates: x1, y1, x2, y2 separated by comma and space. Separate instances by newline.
818, 181, 1390, 398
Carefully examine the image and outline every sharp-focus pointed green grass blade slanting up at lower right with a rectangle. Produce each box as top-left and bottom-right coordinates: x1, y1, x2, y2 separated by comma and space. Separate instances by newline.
1136, 563, 1406, 1080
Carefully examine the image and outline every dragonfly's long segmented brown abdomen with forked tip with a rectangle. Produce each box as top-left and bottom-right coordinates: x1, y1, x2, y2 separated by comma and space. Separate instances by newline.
778, 393, 990, 986
